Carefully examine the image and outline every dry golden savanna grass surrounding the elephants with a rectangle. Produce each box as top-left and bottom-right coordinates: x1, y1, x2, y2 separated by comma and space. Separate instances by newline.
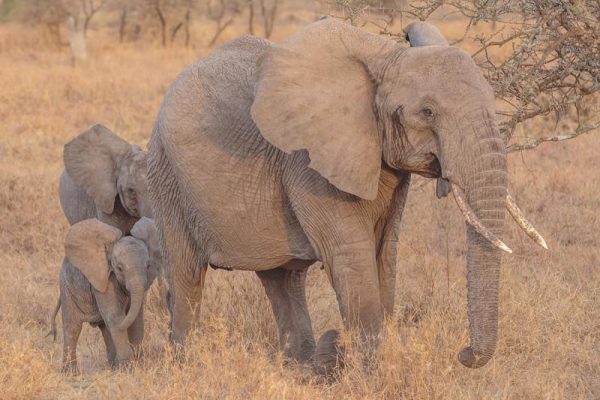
0, 9, 600, 399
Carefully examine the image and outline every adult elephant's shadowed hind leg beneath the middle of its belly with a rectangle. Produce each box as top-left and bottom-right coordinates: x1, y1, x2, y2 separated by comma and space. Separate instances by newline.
257, 268, 315, 363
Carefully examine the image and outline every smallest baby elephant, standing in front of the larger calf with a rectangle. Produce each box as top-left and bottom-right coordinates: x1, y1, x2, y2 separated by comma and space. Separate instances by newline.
50, 217, 160, 372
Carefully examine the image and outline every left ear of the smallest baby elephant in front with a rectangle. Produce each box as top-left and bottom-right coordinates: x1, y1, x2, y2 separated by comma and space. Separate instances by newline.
65, 218, 122, 293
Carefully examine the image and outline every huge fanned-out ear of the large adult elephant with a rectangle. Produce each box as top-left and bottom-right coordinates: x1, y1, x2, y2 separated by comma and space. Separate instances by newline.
251, 18, 397, 200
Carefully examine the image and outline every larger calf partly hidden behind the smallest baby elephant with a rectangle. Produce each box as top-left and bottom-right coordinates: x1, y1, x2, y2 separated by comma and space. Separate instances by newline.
59, 125, 152, 234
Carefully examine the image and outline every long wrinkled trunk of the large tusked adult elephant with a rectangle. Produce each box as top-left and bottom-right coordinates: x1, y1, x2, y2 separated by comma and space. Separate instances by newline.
450, 112, 511, 368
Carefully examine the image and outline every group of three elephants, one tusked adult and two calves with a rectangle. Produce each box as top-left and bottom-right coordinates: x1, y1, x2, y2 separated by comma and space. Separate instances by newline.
52, 18, 546, 373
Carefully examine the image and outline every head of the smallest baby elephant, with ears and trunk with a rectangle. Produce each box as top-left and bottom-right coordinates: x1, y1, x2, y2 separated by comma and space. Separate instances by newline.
65, 218, 156, 329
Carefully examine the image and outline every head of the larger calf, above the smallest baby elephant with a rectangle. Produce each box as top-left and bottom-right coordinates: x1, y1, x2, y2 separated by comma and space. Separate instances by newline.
64, 124, 152, 218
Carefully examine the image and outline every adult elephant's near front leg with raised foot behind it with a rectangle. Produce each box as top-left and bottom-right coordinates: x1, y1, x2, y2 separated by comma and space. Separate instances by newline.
314, 241, 383, 374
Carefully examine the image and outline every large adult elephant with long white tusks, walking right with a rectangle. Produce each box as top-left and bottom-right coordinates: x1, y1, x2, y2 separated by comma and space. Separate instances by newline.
148, 19, 541, 367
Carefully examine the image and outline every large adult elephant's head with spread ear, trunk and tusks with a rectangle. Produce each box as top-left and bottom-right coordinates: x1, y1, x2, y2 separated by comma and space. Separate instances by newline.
251, 19, 548, 367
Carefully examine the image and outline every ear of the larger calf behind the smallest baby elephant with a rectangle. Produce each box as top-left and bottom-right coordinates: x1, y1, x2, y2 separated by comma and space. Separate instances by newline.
63, 124, 131, 214
